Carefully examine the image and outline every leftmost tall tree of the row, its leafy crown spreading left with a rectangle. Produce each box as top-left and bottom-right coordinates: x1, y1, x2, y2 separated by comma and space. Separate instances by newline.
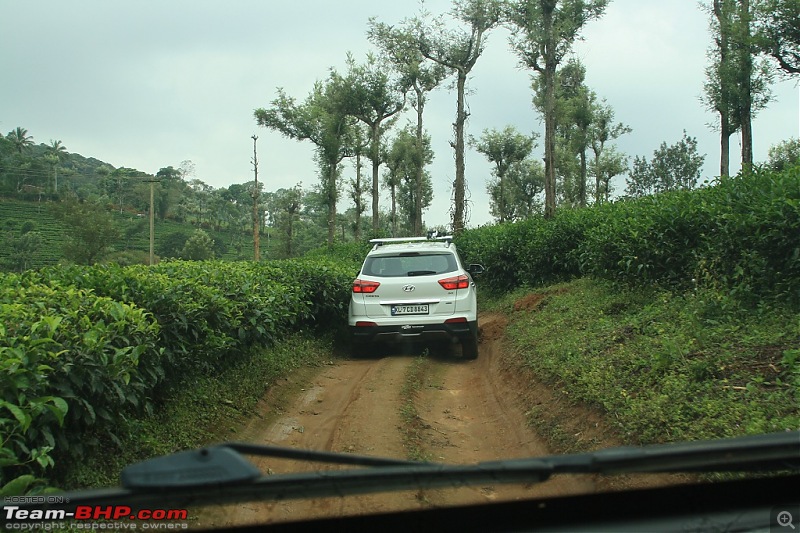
254, 81, 351, 245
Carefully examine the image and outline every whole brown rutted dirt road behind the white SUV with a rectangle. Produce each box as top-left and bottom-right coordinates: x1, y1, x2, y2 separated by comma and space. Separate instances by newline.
198, 316, 595, 527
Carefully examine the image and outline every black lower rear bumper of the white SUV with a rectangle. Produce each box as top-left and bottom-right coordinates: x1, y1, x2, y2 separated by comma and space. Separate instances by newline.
350, 320, 478, 344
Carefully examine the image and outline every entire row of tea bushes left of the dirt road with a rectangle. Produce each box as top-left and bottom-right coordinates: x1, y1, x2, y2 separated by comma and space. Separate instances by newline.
0, 255, 358, 490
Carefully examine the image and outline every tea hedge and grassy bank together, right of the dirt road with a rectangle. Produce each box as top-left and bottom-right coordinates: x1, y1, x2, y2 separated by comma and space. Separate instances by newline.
459, 163, 800, 444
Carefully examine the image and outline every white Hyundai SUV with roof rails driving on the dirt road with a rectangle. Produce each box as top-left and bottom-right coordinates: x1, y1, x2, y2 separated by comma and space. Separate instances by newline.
348, 236, 483, 359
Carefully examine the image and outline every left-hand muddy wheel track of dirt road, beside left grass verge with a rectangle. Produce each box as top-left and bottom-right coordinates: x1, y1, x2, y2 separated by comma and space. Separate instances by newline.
203, 356, 423, 527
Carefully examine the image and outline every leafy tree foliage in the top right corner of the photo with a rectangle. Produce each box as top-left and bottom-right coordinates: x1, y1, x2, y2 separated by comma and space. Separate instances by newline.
755, 0, 800, 75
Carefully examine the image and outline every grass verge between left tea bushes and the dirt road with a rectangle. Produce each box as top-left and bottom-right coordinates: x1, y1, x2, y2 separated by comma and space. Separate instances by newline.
51, 335, 332, 489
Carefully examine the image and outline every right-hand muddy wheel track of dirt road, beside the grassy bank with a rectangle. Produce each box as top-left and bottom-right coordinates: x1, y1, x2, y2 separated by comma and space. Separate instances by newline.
415, 316, 596, 505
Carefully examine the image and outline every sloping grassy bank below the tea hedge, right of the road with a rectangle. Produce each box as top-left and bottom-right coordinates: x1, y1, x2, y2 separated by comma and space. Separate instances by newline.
490, 279, 800, 444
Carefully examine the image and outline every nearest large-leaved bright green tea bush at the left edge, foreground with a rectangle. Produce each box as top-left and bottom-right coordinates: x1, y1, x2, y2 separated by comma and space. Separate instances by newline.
0, 276, 159, 485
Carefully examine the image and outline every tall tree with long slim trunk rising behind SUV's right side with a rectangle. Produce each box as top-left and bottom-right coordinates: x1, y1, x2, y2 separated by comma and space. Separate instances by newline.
417, 0, 502, 233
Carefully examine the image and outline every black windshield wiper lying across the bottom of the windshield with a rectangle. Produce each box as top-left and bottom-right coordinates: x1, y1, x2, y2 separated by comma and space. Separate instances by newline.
9, 431, 800, 509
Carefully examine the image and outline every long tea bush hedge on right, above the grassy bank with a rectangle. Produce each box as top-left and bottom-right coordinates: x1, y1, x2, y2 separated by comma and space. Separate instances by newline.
457, 167, 800, 306
